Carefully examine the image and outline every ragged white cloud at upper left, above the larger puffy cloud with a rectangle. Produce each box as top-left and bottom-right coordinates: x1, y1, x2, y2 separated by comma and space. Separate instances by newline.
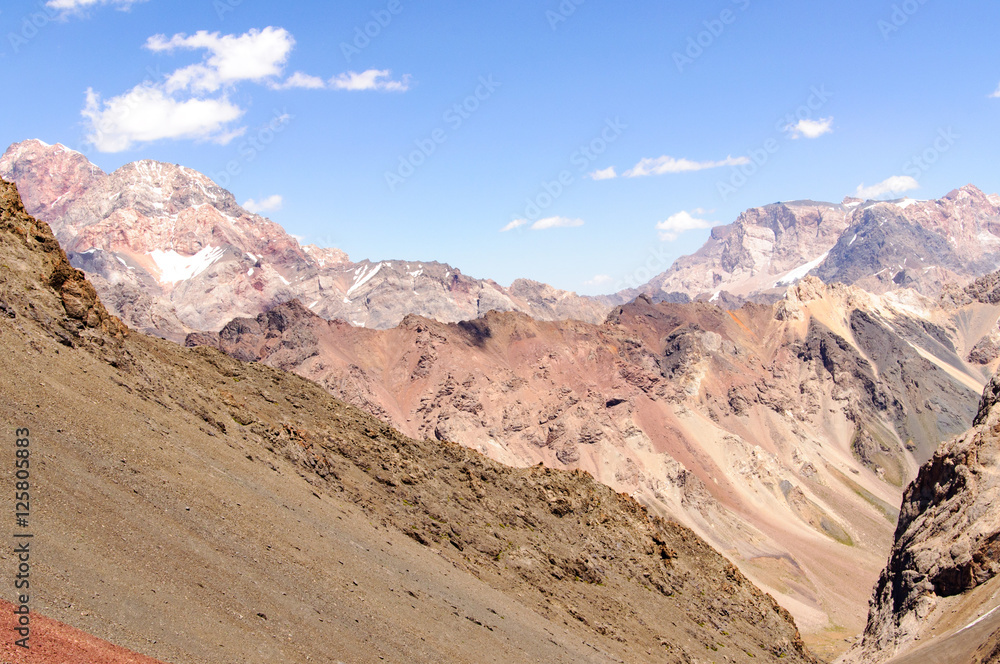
146, 26, 295, 92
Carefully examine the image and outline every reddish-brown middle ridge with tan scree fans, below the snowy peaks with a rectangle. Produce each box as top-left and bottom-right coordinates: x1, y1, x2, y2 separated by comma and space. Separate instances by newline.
189, 278, 998, 656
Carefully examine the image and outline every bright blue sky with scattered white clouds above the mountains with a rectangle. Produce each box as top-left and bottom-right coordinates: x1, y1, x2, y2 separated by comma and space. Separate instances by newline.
0, 0, 1000, 293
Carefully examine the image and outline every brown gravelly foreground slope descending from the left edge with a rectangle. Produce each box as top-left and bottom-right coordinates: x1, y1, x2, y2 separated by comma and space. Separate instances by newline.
0, 176, 813, 664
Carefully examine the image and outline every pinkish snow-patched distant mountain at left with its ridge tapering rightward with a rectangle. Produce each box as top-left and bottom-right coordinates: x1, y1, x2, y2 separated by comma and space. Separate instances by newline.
0, 140, 609, 340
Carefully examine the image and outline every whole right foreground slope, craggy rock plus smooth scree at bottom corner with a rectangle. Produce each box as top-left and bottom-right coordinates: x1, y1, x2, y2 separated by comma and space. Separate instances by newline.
842, 377, 1000, 664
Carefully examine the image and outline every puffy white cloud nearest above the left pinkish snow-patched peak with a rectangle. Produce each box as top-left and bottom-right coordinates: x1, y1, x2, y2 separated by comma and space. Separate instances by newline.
82, 85, 243, 152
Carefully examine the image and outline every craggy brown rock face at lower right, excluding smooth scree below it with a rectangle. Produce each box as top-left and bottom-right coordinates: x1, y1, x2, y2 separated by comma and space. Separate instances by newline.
852, 377, 1000, 662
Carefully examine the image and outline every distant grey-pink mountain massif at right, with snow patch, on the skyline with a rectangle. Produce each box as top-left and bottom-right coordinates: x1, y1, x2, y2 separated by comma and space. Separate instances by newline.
633, 185, 1000, 300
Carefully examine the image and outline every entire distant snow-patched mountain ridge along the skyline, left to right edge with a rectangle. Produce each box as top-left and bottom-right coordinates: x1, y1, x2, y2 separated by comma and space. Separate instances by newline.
0, 140, 1000, 341
